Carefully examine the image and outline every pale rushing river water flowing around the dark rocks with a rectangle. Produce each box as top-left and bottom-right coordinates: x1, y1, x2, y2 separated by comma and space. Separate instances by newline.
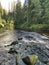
0, 30, 49, 65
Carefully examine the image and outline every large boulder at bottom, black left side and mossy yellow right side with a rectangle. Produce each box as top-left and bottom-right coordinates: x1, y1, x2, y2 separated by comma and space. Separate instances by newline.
22, 55, 38, 65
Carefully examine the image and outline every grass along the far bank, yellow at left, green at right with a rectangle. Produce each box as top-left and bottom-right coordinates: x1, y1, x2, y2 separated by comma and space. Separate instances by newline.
0, 19, 49, 32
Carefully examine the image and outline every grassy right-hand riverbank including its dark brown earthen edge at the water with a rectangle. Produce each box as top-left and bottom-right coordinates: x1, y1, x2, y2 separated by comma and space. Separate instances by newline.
16, 24, 49, 36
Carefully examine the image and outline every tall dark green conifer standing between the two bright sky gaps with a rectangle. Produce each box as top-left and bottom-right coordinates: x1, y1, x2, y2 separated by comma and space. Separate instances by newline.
14, 0, 23, 29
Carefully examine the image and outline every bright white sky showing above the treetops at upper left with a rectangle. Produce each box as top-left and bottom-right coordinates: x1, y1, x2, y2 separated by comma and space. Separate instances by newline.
0, 0, 24, 11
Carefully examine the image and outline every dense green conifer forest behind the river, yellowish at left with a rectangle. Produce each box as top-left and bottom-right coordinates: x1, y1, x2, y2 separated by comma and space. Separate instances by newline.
0, 0, 49, 31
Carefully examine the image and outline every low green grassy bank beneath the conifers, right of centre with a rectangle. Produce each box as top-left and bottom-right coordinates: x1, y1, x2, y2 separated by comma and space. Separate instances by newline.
16, 24, 49, 33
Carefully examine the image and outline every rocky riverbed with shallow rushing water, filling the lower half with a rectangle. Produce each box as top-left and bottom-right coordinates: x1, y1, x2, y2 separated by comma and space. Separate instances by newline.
0, 30, 49, 65
